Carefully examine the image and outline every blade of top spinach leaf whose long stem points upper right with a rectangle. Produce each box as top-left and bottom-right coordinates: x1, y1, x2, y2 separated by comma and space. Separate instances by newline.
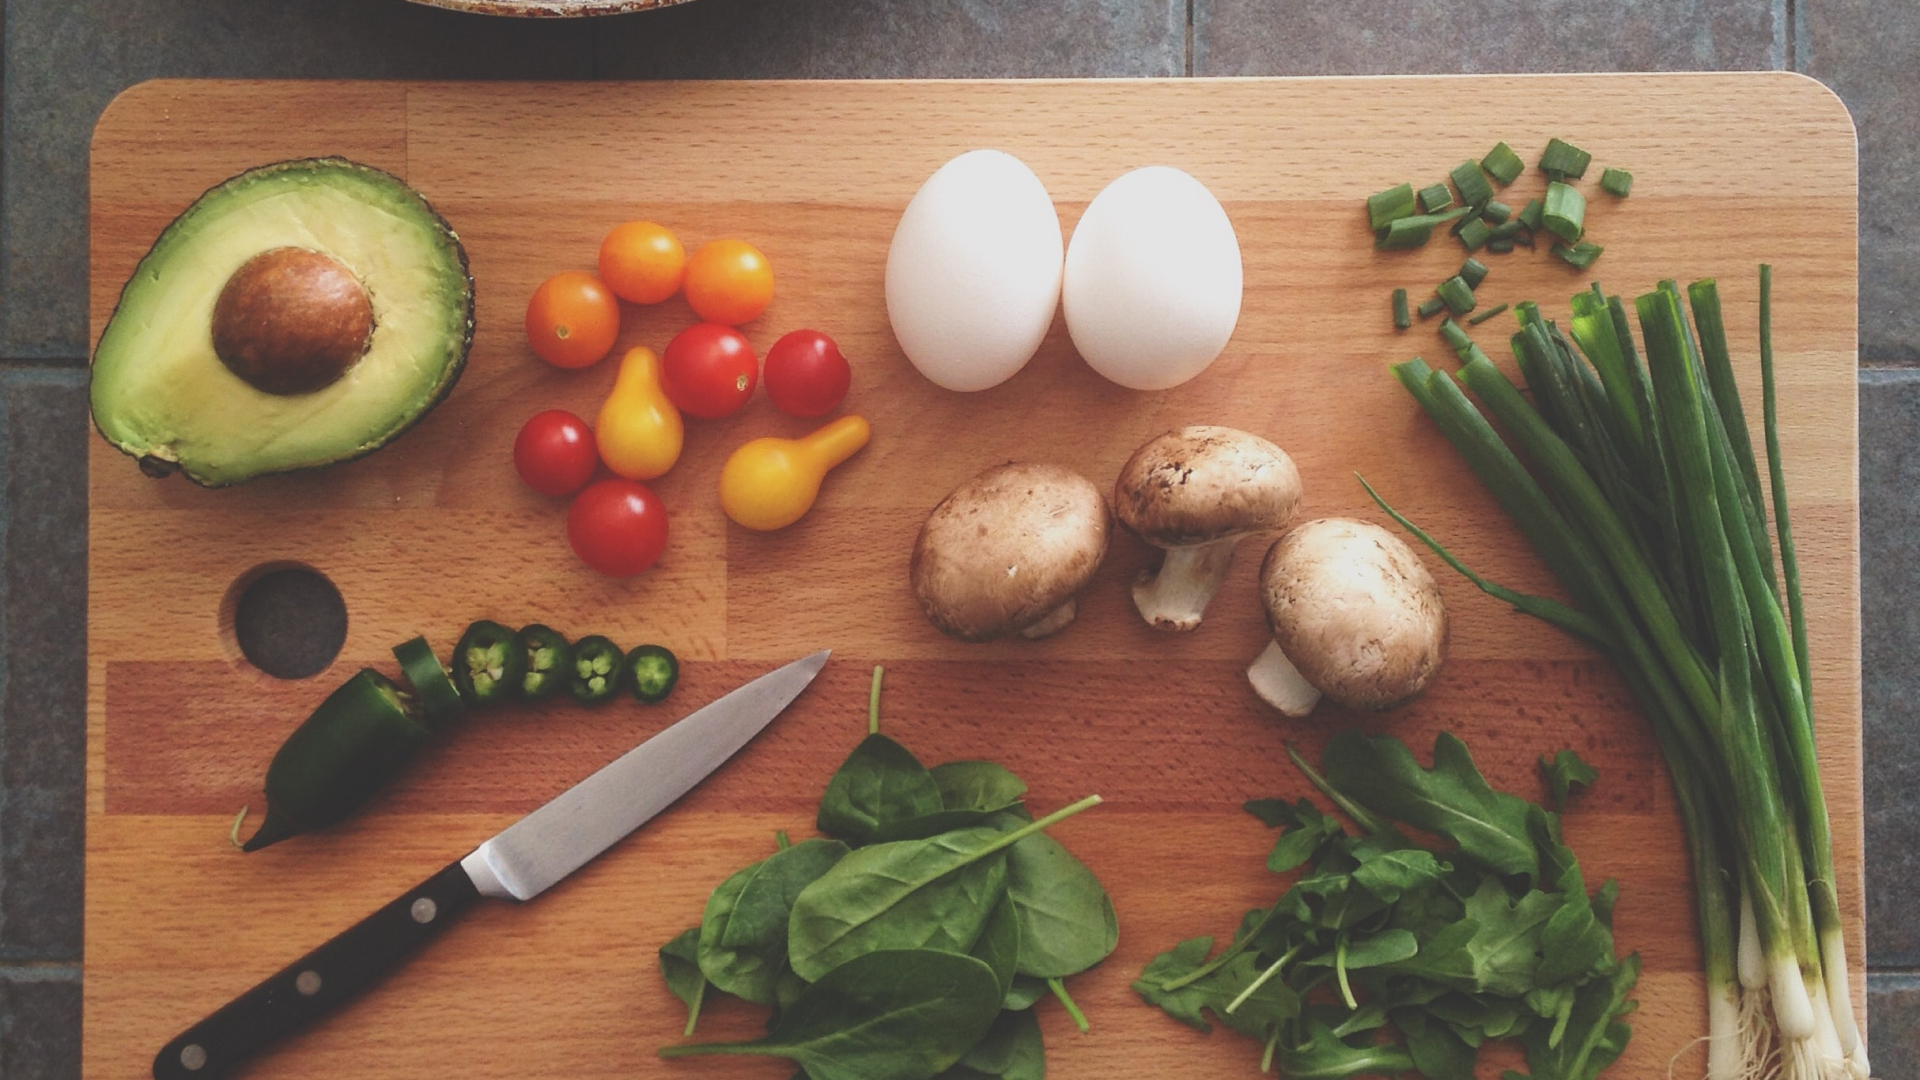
787, 826, 1012, 978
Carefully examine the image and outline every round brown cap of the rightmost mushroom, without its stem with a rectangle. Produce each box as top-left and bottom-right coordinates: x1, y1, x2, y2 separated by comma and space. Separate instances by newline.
1260, 517, 1446, 709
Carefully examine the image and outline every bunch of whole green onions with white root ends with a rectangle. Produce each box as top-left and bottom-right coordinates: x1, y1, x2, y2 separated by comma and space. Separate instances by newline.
1361, 267, 1868, 1080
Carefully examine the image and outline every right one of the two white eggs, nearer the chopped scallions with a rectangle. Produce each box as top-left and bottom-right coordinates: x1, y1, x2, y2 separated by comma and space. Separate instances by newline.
1060, 165, 1240, 390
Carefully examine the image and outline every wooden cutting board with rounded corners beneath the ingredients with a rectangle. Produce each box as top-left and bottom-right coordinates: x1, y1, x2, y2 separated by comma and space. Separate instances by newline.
84, 75, 1864, 1080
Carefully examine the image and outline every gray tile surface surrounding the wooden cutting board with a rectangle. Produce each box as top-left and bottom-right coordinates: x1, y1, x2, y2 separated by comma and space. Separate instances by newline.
0, 0, 1920, 1080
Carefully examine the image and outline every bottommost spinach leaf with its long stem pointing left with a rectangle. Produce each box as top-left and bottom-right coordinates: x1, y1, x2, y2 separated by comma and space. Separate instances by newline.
660, 949, 1000, 1080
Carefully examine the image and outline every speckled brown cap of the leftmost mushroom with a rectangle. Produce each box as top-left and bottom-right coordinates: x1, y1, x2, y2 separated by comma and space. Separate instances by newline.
912, 461, 1108, 642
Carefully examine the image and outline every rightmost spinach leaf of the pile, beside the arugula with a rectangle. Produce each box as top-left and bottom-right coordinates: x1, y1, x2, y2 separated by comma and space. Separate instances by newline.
1006, 832, 1119, 978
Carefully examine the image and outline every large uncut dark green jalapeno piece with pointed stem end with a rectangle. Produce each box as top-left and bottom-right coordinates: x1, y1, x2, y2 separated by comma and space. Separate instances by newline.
244, 669, 432, 851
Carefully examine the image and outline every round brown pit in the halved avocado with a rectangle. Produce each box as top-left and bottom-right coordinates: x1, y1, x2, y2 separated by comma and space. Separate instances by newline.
213, 248, 372, 394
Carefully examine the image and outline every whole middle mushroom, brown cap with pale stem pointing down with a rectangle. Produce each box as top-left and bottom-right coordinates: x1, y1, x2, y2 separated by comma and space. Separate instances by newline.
1114, 425, 1300, 630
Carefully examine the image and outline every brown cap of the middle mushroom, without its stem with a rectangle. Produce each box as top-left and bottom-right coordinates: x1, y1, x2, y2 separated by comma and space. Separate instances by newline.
1114, 425, 1300, 548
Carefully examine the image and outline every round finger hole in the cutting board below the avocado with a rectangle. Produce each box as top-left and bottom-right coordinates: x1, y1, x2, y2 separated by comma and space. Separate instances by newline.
221, 563, 348, 678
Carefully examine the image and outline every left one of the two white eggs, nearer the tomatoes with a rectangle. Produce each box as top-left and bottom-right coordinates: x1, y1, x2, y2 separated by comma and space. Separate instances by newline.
887, 150, 1064, 390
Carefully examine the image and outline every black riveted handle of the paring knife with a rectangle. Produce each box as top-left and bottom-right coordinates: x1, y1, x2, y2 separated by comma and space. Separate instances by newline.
154, 863, 480, 1080
